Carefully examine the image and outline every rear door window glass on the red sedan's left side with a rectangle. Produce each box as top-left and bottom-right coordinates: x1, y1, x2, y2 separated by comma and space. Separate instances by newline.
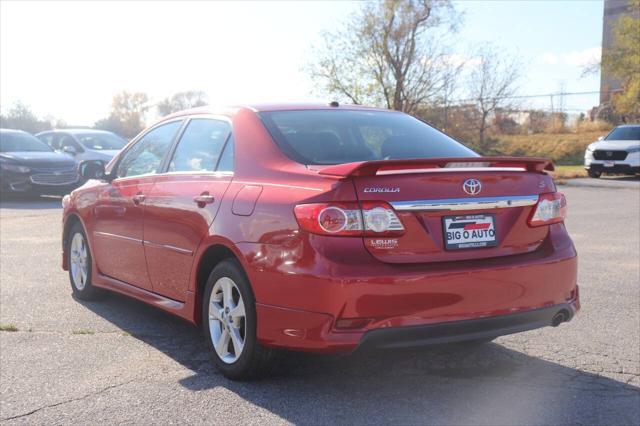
169, 118, 231, 172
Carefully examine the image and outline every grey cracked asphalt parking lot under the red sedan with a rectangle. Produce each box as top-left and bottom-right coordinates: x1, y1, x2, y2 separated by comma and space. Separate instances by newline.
0, 186, 640, 425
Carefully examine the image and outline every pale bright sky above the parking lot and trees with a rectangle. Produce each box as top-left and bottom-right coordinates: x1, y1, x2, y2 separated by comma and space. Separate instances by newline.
0, 0, 603, 125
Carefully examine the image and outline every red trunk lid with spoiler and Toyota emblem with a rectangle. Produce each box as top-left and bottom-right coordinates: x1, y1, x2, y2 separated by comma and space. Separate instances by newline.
318, 157, 555, 263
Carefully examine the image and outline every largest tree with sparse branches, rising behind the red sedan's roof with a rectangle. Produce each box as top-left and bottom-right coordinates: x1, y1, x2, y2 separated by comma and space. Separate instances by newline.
311, 0, 458, 113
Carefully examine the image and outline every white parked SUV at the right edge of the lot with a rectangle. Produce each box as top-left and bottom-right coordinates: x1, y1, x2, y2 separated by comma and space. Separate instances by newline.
584, 124, 640, 178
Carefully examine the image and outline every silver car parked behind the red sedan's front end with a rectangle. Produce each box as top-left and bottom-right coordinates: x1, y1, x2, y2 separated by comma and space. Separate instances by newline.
36, 129, 127, 164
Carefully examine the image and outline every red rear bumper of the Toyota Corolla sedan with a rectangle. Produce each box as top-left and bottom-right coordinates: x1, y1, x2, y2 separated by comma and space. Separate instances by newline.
244, 224, 580, 352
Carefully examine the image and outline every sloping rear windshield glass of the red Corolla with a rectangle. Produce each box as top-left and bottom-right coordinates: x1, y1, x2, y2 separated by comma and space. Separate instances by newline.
260, 110, 478, 165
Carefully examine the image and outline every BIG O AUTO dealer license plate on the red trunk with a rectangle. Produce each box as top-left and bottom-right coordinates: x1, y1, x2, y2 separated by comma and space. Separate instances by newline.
442, 214, 497, 250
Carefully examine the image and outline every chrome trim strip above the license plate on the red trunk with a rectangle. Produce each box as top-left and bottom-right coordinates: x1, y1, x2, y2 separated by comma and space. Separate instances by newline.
390, 195, 538, 211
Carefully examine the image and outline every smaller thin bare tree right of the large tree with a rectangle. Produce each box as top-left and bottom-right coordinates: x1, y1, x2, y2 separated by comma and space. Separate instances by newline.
467, 46, 521, 151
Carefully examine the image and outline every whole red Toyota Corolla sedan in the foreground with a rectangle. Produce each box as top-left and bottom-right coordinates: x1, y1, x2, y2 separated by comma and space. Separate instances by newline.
62, 103, 579, 379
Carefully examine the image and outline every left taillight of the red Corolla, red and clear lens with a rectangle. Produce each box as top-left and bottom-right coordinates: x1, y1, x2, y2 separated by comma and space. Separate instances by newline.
294, 202, 404, 237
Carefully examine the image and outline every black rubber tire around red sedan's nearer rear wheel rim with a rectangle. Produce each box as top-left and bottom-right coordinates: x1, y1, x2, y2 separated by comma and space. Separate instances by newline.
202, 259, 276, 380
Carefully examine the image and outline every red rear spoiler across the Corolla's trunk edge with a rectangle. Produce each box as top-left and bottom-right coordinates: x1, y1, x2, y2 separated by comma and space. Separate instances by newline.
316, 157, 554, 178
